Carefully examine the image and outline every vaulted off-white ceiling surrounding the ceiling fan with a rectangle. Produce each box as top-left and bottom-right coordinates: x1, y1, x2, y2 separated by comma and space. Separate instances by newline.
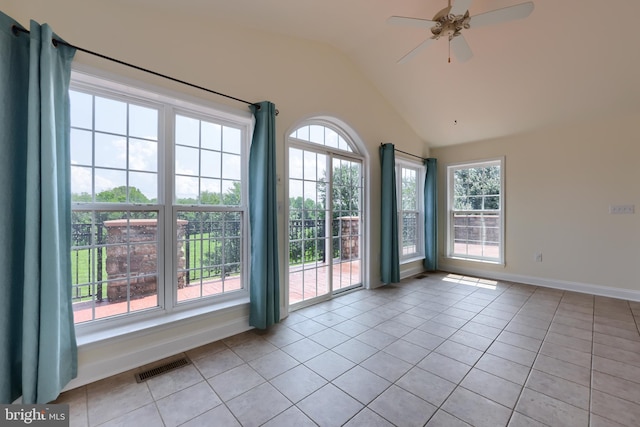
124, 0, 640, 146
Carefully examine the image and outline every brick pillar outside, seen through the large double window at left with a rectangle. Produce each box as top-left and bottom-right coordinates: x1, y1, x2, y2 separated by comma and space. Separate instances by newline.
104, 219, 187, 302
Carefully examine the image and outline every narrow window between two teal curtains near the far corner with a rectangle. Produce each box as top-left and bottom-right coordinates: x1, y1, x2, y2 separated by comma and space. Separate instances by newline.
396, 159, 425, 261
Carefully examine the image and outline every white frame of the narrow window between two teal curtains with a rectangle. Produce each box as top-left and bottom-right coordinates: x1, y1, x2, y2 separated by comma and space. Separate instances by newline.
396, 156, 426, 264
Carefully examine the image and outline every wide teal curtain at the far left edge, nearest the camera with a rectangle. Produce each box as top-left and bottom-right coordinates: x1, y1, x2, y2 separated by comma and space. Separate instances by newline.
0, 13, 77, 403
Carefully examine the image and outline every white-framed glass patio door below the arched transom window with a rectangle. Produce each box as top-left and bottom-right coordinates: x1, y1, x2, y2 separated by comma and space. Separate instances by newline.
288, 145, 364, 306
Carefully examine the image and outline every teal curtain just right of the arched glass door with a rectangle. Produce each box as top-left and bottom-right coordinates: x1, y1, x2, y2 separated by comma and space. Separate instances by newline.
380, 144, 400, 283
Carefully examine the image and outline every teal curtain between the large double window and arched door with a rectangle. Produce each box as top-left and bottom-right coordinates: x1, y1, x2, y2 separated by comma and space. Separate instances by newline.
249, 101, 280, 329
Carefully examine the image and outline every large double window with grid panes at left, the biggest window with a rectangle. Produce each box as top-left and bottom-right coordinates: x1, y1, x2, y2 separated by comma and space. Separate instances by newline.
69, 73, 251, 323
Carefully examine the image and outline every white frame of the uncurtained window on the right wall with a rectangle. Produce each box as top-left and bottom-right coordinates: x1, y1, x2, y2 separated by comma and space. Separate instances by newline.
447, 157, 505, 265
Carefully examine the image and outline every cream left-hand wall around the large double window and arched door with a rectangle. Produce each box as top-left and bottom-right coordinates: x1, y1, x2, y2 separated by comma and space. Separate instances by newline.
0, 0, 428, 385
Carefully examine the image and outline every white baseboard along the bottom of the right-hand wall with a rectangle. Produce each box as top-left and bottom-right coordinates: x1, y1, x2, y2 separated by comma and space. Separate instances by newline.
438, 263, 640, 301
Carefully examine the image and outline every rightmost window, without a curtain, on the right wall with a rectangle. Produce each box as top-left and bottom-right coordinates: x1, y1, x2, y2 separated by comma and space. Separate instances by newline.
447, 159, 504, 263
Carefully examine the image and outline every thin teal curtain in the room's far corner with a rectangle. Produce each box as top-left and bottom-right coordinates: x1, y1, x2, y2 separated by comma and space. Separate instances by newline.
424, 159, 438, 271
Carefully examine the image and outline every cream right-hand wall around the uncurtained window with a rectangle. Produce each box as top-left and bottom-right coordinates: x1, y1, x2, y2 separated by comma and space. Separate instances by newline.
432, 111, 640, 300
